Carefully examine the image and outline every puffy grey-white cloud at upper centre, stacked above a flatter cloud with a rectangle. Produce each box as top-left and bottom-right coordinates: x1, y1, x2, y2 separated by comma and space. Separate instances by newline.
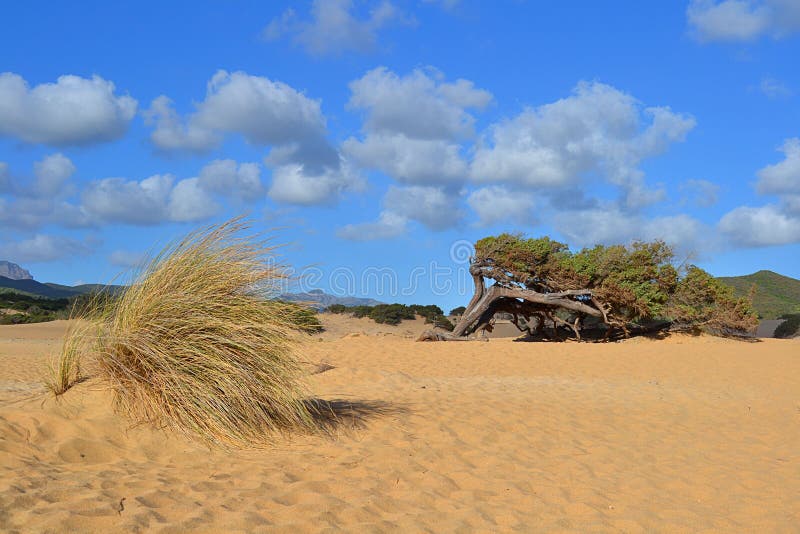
348, 67, 492, 139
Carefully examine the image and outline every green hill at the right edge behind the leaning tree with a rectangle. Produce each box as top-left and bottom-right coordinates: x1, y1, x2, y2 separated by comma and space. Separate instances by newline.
719, 271, 800, 319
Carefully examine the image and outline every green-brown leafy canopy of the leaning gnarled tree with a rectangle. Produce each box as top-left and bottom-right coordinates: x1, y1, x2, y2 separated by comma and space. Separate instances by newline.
473, 234, 757, 332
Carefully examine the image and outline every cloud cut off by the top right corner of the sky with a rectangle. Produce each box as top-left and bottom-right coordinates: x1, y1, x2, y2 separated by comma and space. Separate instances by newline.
686, 0, 800, 42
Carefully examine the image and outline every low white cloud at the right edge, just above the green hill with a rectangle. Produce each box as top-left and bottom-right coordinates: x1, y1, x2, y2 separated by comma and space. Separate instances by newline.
718, 204, 800, 247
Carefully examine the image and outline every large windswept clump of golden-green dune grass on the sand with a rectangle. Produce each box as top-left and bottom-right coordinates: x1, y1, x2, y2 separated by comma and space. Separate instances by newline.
61, 218, 314, 447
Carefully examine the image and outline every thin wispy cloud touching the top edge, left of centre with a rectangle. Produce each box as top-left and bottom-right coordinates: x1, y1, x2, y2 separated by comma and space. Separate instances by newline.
262, 0, 412, 56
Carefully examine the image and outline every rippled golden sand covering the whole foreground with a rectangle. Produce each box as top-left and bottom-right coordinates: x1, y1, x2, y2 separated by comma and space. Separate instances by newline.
0, 319, 800, 532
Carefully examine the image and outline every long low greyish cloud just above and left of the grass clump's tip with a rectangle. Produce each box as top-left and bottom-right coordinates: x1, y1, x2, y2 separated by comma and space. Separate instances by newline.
81, 174, 219, 225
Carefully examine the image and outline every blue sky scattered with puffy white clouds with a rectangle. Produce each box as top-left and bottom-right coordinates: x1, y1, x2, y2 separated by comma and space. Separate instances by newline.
0, 0, 800, 307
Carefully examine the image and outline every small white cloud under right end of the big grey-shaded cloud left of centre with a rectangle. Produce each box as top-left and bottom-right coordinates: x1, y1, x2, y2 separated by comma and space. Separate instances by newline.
267, 162, 365, 206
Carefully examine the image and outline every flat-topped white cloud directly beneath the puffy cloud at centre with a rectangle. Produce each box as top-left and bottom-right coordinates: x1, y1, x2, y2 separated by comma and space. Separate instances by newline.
342, 134, 469, 184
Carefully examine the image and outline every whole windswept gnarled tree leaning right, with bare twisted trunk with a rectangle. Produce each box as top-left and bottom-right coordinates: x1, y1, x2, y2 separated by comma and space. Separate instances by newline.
419, 234, 757, 341
